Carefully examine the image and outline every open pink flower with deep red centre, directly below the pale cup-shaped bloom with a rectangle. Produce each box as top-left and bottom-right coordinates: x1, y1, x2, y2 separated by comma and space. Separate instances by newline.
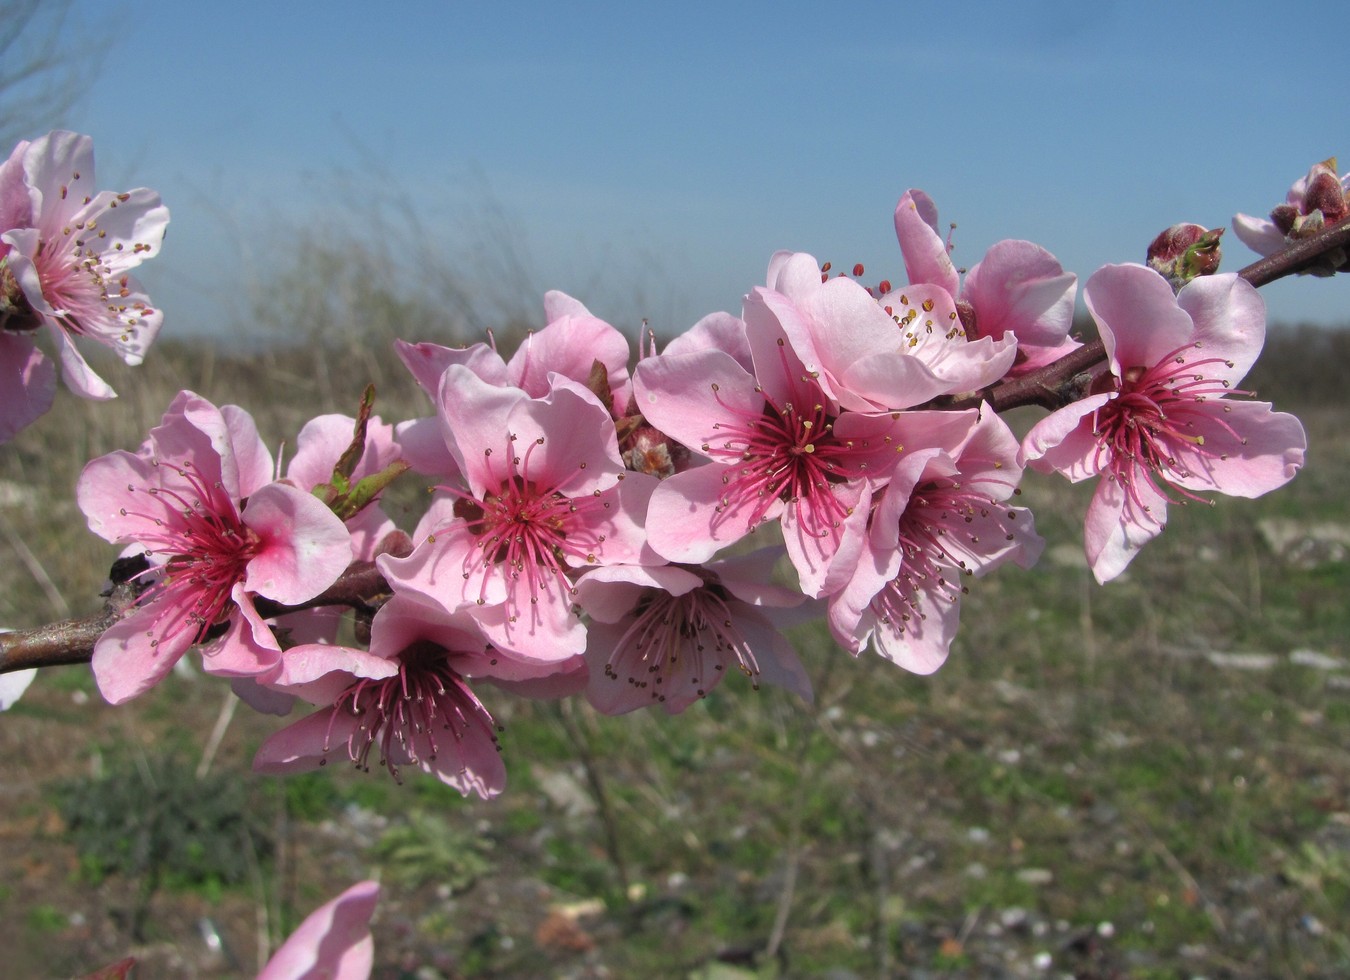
633, 310, 898, 595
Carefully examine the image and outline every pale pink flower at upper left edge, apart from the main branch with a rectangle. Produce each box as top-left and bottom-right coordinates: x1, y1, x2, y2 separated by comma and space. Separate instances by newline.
0, 131, 169, 398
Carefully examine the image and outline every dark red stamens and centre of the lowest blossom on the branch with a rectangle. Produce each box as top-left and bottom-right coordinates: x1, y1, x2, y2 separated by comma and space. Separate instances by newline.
320, 643, 497, 783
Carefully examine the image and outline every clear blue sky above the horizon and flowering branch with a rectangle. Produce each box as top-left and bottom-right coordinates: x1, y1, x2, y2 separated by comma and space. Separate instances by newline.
18, 0, 1350, 344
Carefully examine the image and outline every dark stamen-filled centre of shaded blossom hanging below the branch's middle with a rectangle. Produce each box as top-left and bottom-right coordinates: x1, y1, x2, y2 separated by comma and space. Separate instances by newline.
605, 584, 760, 702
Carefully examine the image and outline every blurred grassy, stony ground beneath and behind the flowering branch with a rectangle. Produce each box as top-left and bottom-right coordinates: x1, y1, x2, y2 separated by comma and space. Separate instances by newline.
0, 326, 1350, 977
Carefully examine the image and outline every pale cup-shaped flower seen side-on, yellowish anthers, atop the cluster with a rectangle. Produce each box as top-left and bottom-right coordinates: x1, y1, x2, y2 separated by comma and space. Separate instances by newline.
761, 252, 1015, 412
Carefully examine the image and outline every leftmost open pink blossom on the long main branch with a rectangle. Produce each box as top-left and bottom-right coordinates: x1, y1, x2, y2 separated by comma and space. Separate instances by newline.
76, 391, 351, 703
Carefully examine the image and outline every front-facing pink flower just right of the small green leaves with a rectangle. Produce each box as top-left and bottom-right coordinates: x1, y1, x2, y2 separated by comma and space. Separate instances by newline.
378, 364, 655, 661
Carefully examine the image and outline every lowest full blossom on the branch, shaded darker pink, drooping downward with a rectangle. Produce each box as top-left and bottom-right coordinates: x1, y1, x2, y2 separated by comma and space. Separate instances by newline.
254, 595, 521, 799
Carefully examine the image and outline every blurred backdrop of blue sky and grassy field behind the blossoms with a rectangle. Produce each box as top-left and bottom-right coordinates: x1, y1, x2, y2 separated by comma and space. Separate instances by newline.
0, 0, 1350, 979
